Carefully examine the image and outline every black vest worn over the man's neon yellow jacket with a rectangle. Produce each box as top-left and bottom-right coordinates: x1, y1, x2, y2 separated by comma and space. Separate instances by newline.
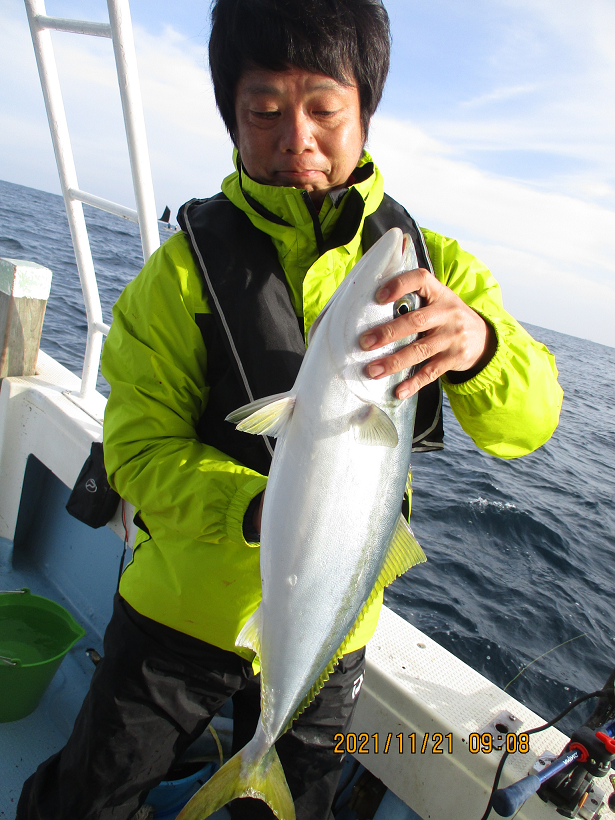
177, 189, 443, 475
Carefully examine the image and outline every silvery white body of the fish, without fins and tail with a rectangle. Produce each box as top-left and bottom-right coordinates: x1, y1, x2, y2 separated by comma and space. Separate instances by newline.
260, 230, 424, 740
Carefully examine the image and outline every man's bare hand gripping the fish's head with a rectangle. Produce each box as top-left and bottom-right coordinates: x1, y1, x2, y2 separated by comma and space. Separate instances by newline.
359, 268, 497, 399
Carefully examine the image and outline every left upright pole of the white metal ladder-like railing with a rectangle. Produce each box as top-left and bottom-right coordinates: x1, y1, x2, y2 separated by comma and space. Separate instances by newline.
25, 0, 103, 397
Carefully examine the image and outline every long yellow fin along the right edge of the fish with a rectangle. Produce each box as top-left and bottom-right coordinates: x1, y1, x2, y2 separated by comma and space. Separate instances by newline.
282, 513, 427, 731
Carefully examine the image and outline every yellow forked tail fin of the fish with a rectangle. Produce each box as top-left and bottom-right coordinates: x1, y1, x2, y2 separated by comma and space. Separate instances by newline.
177, 738, 295, 820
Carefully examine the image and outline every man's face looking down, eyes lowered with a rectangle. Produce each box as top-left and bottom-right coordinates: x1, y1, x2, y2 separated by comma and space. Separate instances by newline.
235, 68, 363, 204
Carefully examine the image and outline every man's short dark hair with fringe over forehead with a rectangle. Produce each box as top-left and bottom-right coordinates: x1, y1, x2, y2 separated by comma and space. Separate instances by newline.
209, 0, 391, 142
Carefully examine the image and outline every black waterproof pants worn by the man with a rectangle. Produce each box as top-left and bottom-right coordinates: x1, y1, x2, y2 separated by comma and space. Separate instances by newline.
16, 595, 365, 820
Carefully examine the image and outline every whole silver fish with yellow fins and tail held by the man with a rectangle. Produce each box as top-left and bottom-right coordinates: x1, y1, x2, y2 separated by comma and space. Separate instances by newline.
178, 228, 426, 820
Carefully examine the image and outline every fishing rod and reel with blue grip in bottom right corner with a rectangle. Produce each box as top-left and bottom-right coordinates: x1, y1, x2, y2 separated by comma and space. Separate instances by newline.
481, 669, 615, 820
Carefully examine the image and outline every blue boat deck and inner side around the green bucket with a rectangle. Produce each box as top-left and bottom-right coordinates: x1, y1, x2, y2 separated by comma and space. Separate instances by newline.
0, 460, 123, 820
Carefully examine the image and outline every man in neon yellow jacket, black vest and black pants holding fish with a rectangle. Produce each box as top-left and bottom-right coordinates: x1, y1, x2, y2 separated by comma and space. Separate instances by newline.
18, 0, 561, 820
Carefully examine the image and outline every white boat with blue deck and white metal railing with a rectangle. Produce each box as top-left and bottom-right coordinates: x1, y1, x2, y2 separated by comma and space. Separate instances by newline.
0, 0, 615, 820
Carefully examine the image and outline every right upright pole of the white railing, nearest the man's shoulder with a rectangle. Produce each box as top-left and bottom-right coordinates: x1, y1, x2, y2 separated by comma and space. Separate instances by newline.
107, 0, 160, 261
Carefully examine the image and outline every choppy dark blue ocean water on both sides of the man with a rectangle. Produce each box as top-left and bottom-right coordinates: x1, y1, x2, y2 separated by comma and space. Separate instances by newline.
0, 181, 615, 731
